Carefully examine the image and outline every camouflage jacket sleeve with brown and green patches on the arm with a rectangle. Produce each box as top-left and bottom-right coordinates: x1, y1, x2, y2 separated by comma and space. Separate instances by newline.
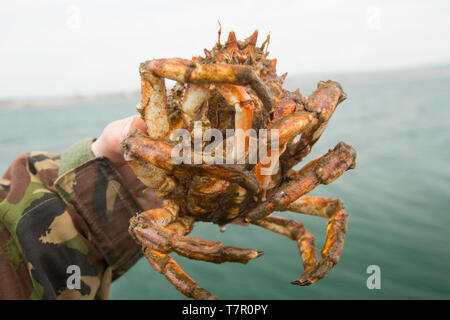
0, 140, 141, 299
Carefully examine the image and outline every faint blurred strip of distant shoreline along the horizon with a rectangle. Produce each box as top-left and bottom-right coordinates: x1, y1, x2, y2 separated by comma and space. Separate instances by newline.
0, 65, 450, 109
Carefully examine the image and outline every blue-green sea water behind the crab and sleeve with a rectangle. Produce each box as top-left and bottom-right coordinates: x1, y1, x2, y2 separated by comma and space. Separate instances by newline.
0, 74, 450, 299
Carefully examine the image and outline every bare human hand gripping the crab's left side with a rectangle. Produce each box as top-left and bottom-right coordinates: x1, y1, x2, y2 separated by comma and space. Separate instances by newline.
91, 115, 162, 210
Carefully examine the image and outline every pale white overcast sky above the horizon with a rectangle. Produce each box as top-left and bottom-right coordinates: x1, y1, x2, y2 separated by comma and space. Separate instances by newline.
0, 0, 450, 99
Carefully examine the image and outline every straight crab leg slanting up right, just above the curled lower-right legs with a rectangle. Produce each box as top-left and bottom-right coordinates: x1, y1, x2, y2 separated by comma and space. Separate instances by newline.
245, 142, 356, 221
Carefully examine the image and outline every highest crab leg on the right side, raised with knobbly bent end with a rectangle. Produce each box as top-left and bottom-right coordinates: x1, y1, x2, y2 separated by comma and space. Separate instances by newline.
280, 80, 347, 172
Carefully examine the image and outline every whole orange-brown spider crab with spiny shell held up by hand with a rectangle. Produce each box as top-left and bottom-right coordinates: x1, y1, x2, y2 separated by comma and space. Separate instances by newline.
121, 30, 356, 299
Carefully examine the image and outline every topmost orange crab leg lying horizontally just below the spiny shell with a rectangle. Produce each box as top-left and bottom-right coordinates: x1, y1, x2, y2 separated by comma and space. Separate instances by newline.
144, 58, 273, 111
